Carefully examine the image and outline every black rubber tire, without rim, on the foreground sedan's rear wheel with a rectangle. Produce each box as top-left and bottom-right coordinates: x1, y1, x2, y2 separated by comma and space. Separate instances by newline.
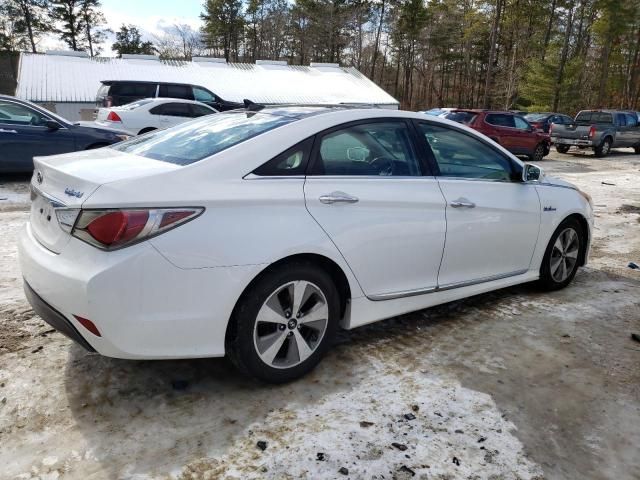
225, 261, 340, 383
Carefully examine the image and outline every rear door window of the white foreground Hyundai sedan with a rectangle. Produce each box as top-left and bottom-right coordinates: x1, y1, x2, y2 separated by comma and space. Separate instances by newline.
311, 121, 420, 176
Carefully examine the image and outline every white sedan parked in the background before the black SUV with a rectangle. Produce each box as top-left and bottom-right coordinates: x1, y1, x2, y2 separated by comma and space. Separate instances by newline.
96, 98, 218, 135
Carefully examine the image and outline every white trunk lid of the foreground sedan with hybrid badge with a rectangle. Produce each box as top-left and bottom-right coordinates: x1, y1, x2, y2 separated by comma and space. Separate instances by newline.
30, 148, 181, 253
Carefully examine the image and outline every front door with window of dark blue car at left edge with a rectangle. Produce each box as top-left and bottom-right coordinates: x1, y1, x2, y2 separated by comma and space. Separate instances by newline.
0, 100, 75, 172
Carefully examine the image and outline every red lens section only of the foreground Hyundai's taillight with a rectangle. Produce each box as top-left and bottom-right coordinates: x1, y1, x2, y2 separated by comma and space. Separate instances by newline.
86, 210, 149, 245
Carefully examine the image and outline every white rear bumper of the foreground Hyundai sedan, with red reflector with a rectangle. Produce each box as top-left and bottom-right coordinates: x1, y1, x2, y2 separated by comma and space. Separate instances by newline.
18, 220, 263, 359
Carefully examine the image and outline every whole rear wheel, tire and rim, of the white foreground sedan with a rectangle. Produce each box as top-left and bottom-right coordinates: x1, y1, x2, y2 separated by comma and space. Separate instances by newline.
226, 262, 340, 383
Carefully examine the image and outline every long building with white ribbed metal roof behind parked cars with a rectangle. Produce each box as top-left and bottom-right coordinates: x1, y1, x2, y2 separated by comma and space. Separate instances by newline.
16, 52, 398, 120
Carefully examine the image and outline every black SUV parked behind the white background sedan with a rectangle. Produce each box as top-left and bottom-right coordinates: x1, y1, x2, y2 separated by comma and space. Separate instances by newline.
96, 80, 244, 112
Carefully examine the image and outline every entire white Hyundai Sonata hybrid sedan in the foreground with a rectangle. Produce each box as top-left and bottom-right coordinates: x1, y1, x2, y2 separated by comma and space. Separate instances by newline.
19, 105, 593, 382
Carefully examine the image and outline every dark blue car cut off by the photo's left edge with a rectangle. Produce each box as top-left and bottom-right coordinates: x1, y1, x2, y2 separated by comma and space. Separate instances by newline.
0, 95, 129, 172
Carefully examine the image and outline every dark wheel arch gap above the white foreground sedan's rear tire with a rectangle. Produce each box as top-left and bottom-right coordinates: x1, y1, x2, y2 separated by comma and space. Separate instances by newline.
225, 253, 351, 344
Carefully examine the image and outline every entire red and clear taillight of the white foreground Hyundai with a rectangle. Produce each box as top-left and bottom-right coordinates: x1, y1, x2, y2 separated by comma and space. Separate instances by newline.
71, 207, 204, 250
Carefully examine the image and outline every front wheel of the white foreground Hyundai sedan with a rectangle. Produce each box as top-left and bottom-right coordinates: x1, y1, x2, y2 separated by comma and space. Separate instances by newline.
538, 218, 585, 290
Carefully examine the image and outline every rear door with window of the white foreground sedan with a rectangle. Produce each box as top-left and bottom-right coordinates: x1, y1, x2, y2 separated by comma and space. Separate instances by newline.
304, 119, 446, 300
